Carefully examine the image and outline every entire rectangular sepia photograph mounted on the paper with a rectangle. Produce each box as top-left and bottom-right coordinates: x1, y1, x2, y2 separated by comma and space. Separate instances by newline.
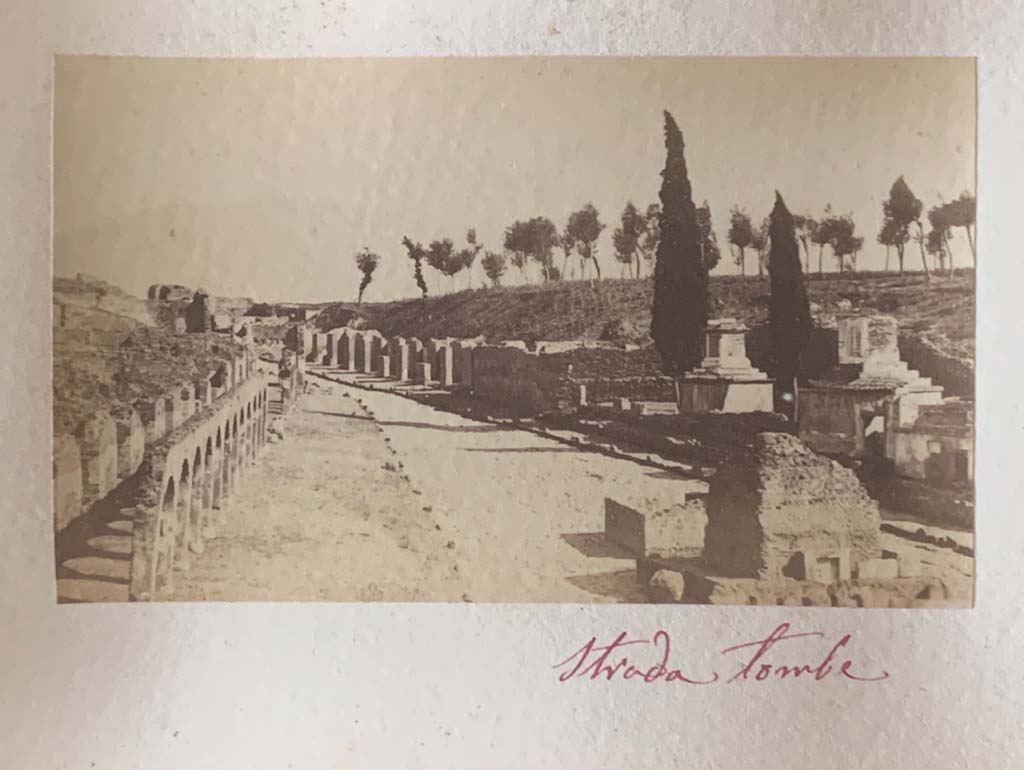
52, 56, 974, 608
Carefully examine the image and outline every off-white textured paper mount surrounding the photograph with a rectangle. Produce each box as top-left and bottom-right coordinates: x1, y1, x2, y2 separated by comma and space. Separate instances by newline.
0, 0, 1024, 770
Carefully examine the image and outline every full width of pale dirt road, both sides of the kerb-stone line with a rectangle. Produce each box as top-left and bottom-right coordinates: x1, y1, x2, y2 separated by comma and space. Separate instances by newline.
170, 381, 701, 602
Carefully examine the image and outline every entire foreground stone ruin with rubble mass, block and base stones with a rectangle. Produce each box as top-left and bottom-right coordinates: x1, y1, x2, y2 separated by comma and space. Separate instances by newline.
605, 433, 950, 606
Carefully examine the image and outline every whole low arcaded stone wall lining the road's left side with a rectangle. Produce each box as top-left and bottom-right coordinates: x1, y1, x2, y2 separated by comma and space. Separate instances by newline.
129, 376, 268, 601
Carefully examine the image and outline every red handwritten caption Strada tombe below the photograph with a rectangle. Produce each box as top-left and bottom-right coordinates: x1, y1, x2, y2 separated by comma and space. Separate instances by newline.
552, 623, 889, 685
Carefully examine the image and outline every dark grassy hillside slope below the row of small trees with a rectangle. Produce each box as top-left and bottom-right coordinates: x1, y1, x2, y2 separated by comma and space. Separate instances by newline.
315, 270, 975, 368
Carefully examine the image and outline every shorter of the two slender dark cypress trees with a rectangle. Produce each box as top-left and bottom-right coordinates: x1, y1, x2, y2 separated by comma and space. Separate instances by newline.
768, 190, 811, 417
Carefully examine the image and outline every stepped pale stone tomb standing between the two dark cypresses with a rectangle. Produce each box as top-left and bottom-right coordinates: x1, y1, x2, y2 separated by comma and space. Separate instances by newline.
679, 318, 774, 414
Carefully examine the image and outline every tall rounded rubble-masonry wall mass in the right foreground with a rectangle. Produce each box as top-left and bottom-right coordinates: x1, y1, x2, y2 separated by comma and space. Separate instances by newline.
705, 433, 882, 580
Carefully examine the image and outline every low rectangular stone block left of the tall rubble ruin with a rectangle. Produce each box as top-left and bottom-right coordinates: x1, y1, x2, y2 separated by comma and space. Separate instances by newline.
604, 493, 708, 558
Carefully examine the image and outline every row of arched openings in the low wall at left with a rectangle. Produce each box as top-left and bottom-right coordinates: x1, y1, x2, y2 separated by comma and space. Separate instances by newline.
146, 381, 268, 597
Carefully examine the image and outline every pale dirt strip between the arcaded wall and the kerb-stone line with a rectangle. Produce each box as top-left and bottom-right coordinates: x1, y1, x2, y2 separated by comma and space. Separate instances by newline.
168, 388, 469, 601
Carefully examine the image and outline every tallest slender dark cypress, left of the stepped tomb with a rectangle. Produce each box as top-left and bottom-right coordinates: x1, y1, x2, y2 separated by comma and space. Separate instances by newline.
650, 111, 708, 393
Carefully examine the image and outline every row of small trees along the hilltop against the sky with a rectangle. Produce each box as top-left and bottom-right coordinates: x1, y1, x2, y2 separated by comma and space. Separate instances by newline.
355, 169, 976, 302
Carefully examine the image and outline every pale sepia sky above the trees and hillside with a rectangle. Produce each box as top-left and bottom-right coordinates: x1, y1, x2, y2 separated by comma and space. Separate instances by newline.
54, 57, 976, 301
